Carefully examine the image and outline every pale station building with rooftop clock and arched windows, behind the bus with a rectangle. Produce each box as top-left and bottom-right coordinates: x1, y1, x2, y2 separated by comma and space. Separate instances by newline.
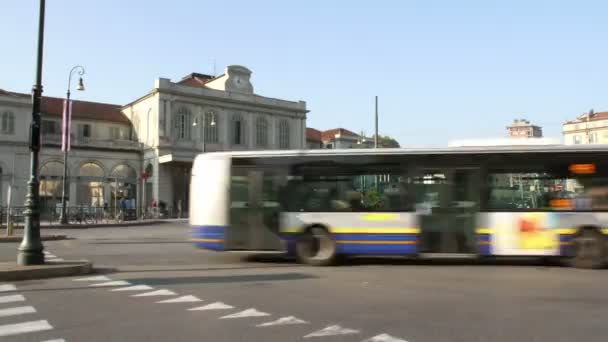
0, 65, 308, 218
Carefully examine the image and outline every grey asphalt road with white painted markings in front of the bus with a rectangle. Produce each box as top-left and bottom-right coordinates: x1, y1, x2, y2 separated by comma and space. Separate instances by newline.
0, 223, 608, 342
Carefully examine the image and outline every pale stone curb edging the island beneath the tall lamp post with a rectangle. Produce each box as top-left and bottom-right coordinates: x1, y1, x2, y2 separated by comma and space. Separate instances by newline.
0, 260, 93, 281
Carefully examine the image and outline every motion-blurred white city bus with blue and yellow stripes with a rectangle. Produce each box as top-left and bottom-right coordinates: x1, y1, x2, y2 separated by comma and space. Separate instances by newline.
189, 145, 608, 268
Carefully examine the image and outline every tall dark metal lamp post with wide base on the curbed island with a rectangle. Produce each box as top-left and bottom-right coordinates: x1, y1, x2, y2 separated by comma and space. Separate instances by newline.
17, 0, 45, 266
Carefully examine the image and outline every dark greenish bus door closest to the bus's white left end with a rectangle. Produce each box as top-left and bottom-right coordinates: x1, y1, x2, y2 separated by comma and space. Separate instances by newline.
225, 168, 282, 251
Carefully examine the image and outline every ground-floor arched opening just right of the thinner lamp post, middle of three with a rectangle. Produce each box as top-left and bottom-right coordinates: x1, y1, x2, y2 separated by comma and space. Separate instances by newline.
78, 162, 104, 207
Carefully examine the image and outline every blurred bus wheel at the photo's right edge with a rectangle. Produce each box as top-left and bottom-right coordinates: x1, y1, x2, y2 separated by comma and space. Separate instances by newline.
570, 228, 606, 269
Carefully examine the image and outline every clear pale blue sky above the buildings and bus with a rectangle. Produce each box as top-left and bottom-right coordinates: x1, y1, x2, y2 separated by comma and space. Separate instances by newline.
0, 0, 608, 146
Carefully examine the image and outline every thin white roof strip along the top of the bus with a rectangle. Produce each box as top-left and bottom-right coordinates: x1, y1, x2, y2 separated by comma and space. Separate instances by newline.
198, 144, 608, 158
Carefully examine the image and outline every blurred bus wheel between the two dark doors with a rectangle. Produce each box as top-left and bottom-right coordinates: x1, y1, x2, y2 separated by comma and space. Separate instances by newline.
296, 226, 337, 266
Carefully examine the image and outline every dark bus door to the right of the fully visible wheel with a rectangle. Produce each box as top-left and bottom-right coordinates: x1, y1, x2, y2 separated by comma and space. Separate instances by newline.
414, 169, 479, 254
